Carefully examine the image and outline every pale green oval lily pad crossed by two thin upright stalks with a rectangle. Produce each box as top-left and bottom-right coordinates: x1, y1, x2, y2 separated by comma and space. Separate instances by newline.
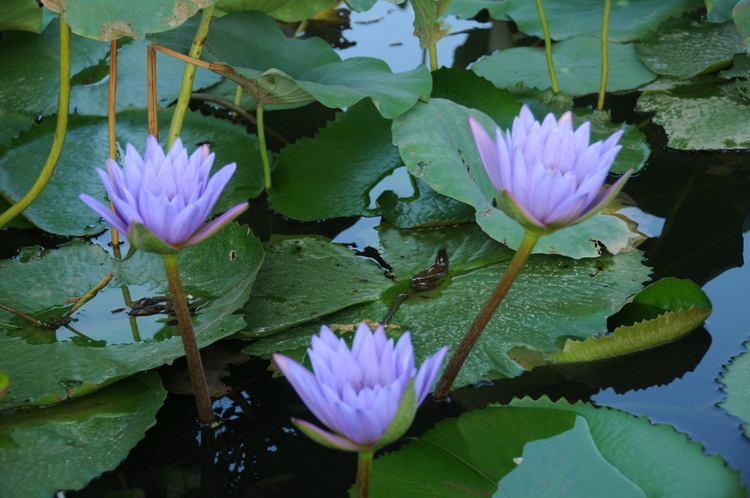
471, 36, 656, 95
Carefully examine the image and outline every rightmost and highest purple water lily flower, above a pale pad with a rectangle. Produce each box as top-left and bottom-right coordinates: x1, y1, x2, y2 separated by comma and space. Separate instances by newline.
469, 105, 632, 235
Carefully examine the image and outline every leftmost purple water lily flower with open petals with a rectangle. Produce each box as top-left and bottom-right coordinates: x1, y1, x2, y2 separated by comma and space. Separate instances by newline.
80, 136, 248, 254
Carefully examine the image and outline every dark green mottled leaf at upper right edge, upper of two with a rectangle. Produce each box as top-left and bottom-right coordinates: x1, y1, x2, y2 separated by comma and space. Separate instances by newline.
636, 16, 744, 79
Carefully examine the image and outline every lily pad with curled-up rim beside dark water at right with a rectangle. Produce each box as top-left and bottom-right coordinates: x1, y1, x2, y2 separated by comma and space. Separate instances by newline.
547, 277, 711, 362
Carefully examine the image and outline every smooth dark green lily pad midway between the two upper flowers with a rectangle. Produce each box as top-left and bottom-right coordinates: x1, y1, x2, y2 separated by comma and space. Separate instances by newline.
268, 102, 403, 221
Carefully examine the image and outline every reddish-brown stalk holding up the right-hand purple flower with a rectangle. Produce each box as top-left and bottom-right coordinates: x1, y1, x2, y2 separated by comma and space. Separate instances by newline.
432, 232, 540, 399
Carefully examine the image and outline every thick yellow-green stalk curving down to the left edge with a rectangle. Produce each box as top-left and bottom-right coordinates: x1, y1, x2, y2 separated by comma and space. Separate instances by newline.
0, 17, 70, 228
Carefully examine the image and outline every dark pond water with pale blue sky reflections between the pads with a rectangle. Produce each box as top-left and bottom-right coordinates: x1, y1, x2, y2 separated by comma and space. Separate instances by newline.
2, 2, 750, 497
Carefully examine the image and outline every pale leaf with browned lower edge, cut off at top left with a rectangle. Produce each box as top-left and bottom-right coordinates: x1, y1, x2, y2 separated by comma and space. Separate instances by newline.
42, 0, 216, 41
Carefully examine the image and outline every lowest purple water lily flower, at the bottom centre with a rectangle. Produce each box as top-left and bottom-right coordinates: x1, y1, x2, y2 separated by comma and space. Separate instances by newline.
273, 323, 448, 451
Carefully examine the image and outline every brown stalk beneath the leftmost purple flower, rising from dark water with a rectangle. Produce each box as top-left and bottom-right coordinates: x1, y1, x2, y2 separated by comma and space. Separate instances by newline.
161, 254, 215, 425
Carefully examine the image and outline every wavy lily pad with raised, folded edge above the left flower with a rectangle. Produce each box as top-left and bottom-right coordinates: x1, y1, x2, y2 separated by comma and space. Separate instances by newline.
157, 11, 432, 118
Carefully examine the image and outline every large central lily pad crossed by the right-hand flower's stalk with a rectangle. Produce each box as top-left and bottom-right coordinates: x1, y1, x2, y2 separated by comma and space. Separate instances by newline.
245, 225, 649, 386
